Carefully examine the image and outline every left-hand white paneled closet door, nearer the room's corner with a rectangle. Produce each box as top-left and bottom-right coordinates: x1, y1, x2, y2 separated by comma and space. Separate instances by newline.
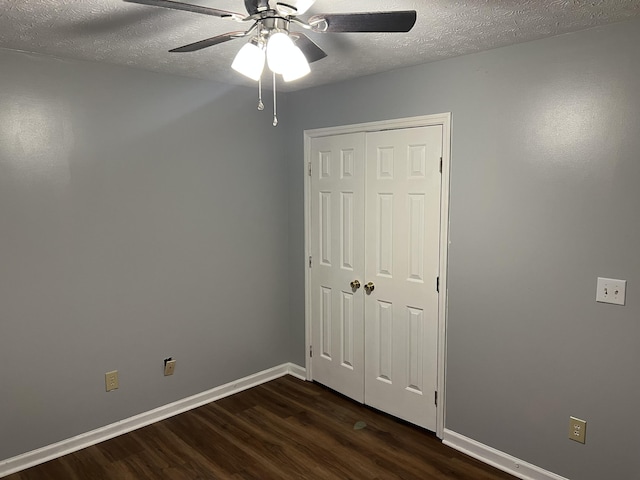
311, 133, 365, 402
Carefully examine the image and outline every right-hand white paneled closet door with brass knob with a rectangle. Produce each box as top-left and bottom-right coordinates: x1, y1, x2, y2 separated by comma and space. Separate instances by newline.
364, 126, 442, 430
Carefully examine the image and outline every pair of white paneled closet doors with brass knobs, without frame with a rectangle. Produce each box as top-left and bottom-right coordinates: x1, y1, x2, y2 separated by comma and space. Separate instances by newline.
310, 126, 443, 431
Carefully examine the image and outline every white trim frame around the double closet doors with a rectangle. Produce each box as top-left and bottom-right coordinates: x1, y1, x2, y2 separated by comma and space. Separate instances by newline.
304, 113, 451, 438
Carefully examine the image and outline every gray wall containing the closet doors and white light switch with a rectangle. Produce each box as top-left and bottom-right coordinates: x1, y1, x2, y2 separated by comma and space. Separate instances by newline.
283, 16, 640, 480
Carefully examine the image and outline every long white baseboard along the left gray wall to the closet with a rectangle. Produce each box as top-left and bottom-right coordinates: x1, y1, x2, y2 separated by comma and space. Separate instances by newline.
0, 363, 306, 478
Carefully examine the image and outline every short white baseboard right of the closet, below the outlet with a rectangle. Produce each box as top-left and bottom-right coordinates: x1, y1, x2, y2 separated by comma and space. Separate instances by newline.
442, 428, 569, 480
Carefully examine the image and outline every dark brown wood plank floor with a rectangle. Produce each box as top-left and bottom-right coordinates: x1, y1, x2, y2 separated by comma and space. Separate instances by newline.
6, 376, 514, 480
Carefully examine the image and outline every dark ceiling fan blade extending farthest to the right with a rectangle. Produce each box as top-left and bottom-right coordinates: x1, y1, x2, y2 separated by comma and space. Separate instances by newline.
308, 10, 417, 33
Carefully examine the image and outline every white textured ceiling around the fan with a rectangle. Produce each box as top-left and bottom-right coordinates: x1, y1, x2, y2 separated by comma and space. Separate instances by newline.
0, 0, 640, 90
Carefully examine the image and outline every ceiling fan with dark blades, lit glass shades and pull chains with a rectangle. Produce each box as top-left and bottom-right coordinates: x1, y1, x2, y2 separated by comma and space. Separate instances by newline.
124, 0, 417, 126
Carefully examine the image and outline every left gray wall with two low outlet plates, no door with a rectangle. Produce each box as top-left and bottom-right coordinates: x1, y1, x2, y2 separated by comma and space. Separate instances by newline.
0, 50, 299, 459
